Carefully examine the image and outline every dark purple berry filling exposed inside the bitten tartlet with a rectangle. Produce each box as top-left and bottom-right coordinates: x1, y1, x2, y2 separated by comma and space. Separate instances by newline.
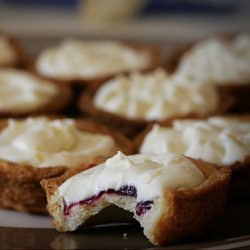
63, 186, 154, 216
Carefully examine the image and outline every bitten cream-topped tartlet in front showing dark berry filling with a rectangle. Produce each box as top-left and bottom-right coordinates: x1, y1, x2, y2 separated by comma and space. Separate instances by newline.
41, 152, 230, 245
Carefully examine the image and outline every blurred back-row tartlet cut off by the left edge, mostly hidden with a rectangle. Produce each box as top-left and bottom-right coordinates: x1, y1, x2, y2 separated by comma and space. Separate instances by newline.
0, 32, 24, 67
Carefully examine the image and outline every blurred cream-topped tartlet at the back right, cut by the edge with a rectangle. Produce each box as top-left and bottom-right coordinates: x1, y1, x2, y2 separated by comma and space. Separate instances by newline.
167, 33, 250, 112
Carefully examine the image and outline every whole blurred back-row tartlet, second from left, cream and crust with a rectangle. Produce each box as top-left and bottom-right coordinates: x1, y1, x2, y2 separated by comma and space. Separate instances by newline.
29, 39, 161, 110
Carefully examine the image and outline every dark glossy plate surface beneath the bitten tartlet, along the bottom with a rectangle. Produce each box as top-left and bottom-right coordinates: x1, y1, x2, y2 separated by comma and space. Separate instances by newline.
0, 203, 250, 249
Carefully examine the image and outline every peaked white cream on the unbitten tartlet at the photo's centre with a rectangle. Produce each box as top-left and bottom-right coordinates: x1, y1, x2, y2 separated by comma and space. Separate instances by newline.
94, 69, 218, 120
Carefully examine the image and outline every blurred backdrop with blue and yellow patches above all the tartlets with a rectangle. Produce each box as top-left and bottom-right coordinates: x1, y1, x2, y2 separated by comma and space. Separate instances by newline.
0, 0, 250, 43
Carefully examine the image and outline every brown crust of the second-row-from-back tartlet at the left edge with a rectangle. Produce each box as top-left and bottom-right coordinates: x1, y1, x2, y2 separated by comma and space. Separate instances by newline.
0, 71, 73, 118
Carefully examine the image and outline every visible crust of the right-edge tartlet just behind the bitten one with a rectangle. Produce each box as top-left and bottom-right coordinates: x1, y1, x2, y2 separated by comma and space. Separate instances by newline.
133, 115, 250, 202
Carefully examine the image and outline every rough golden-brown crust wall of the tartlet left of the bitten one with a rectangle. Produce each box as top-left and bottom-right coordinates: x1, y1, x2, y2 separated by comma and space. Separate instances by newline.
0, 160, 66, 213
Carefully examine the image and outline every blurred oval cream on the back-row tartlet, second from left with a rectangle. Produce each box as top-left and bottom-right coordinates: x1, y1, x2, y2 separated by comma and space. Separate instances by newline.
36, 40, 150, 80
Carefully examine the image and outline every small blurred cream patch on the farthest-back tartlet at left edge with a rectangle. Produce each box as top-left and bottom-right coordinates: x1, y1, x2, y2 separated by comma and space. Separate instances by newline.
0, 35, 17, 65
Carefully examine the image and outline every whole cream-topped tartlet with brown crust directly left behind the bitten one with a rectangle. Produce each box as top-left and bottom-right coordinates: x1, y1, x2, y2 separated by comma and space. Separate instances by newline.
0, 117, 133, 213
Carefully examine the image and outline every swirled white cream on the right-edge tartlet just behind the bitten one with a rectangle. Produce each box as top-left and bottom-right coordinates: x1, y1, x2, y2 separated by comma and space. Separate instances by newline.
140, 117, 250, 165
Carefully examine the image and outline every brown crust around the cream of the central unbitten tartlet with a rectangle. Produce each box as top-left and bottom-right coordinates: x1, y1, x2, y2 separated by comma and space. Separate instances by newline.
78, 82, 234, 138
